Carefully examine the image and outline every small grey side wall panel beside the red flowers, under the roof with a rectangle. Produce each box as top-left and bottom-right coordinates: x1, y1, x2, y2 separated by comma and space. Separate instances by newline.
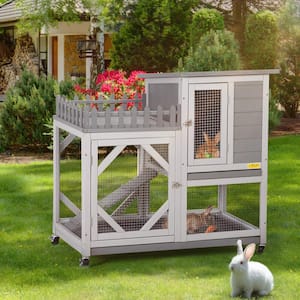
148, 83, 178, 110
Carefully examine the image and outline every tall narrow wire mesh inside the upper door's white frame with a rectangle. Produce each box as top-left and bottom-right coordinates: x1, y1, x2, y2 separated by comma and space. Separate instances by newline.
194, 89, 221, 159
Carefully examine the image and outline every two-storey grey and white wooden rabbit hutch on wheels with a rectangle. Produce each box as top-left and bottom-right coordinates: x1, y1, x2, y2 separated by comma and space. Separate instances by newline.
51, 70, 278, 265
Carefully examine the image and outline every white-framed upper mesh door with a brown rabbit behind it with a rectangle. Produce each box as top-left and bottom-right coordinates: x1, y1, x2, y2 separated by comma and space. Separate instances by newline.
188, 84, 227, 165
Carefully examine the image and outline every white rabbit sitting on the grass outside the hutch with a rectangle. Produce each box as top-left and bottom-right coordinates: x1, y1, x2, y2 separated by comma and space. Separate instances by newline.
229, 240, 274, 299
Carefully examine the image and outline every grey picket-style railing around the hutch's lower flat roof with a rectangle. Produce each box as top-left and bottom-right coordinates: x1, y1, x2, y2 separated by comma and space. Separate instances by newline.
56, 96, 180, 132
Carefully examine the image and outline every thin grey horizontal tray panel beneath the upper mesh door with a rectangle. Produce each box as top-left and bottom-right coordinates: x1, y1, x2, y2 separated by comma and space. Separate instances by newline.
188, 170, 261, 180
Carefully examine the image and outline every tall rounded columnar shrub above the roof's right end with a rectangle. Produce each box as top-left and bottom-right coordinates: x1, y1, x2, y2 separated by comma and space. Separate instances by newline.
245, 10, 278, 69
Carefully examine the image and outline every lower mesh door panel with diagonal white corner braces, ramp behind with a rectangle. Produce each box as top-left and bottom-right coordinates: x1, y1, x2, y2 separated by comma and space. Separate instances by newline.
91, 144, 169, 239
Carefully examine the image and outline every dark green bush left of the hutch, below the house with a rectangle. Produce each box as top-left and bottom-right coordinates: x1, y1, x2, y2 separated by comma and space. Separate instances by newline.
0, 70, 74, 150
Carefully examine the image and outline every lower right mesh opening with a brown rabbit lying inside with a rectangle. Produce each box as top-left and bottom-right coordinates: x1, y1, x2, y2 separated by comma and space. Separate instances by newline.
187, 183, 260, 234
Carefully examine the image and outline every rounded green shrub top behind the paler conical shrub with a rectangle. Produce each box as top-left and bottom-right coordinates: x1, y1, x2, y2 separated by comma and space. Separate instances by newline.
191, 8, 224, 47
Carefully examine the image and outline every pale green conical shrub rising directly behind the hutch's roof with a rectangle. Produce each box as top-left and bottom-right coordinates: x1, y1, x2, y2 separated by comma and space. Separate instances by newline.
178, 30, 239, 72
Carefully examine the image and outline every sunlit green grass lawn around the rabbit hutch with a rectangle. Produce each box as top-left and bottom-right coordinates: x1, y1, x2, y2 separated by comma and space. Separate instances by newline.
0, 136, 300, 300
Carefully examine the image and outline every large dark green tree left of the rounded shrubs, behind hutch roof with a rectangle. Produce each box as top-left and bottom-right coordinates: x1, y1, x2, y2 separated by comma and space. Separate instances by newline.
111, 0, 194, 72
